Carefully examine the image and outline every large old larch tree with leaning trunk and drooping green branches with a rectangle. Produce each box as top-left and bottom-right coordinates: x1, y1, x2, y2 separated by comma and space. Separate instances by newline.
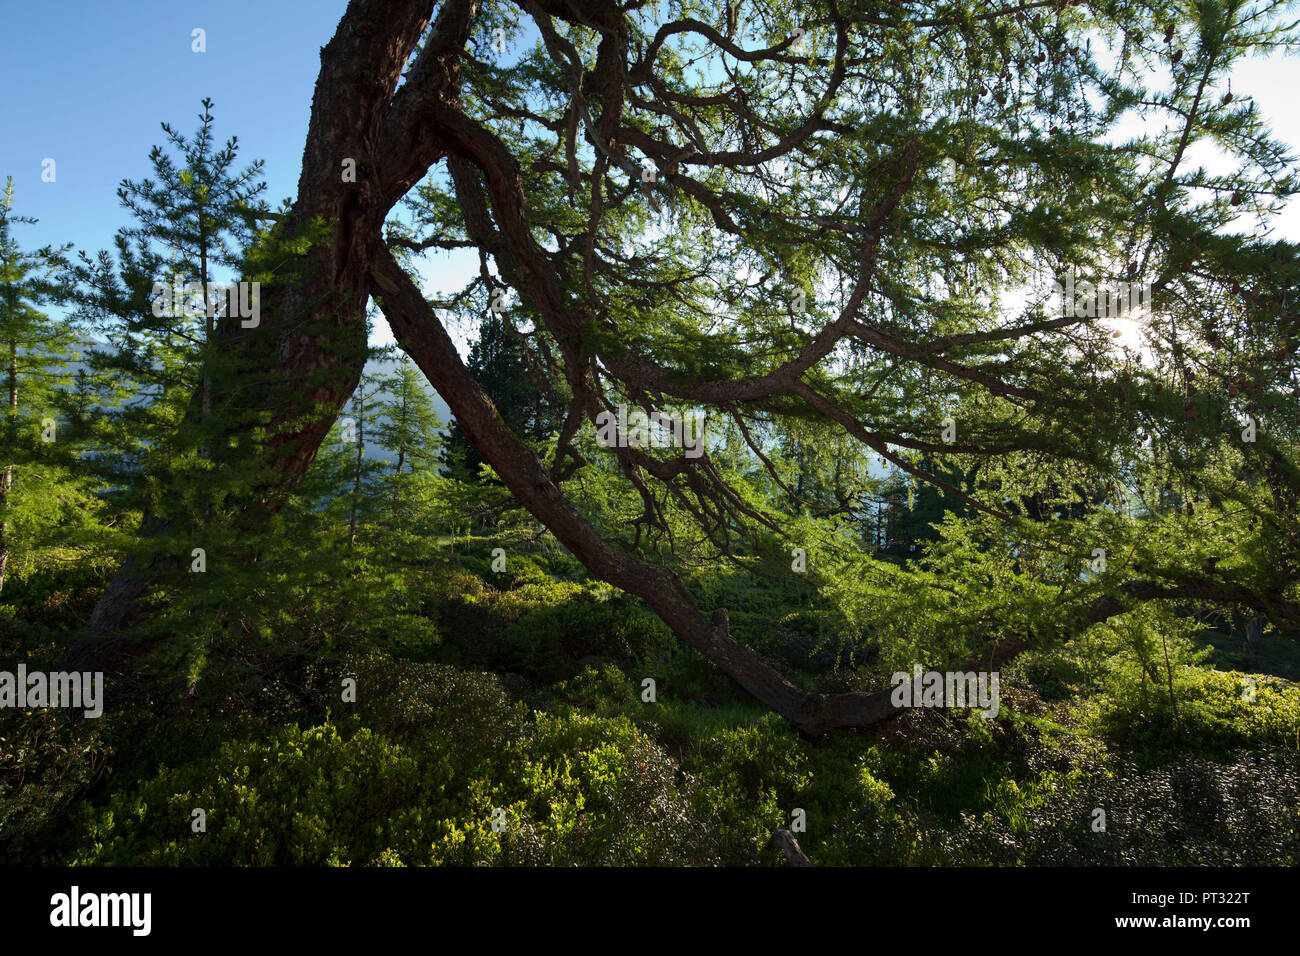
71, 0, 1300, 734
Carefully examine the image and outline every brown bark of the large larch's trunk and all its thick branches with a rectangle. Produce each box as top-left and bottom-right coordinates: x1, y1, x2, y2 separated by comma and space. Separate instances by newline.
73, 0, 1268, 738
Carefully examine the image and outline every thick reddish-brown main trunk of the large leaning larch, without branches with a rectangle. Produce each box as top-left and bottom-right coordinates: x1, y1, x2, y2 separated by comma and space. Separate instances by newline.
87, 0, 475, 641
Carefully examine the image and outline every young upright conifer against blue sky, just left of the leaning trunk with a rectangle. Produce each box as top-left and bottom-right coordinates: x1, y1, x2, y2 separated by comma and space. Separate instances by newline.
64, 99, 267, 553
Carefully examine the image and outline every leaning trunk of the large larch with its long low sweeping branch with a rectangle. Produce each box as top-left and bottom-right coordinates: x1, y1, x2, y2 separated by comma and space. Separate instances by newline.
76, 0, 1222, 735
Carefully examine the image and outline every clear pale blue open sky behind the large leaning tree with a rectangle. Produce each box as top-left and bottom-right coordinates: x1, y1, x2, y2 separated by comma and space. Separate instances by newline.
0, 0, 1300, 351
